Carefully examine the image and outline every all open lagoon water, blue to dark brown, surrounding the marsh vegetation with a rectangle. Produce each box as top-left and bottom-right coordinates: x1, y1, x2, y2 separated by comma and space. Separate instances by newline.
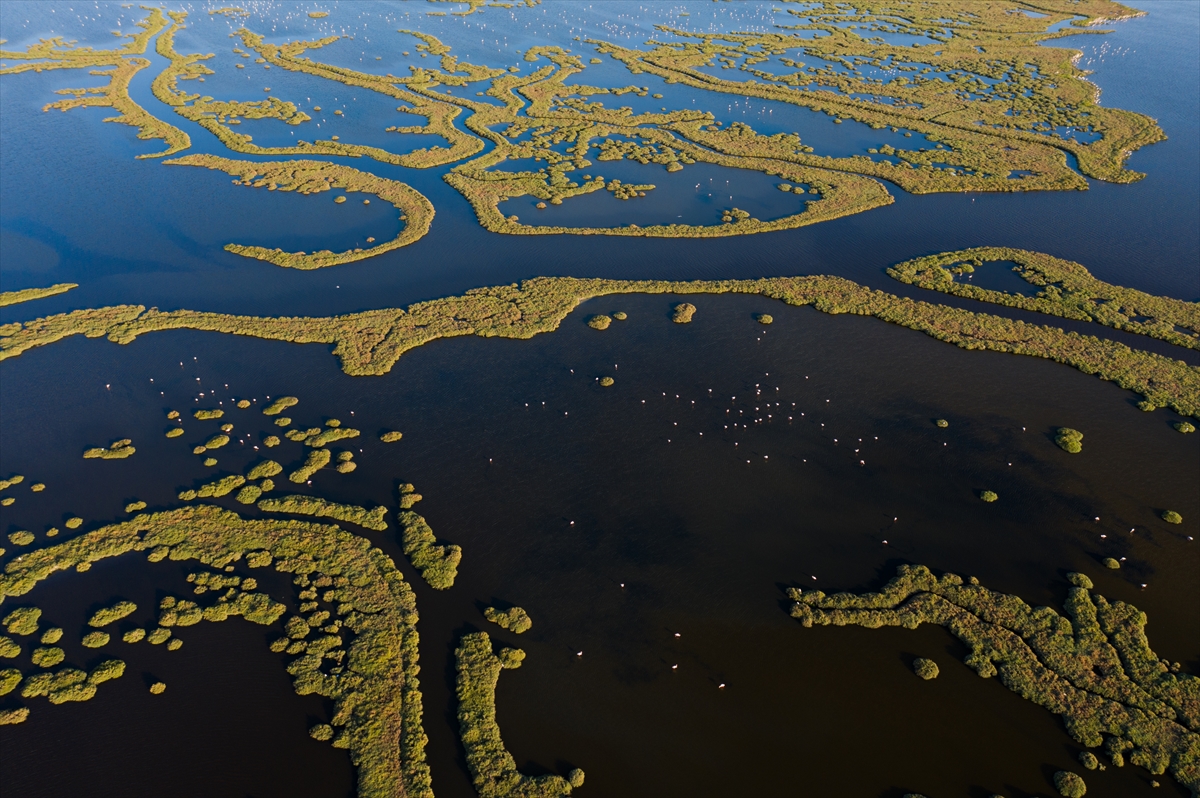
0, 2, 1200, 796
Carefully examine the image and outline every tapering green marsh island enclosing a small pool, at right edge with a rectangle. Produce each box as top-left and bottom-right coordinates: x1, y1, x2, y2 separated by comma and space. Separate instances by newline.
888, 247, 1200, 349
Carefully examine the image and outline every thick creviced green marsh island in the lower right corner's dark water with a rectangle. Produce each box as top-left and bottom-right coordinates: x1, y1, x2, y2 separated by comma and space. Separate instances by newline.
788, 565, 1200, 792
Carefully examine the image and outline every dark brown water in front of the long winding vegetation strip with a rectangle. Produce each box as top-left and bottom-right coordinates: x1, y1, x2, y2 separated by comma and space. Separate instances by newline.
0, 296, 1200, 796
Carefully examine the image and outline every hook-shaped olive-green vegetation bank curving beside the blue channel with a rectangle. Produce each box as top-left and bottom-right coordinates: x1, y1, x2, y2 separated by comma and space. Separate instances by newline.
164, 155, 433, 269
